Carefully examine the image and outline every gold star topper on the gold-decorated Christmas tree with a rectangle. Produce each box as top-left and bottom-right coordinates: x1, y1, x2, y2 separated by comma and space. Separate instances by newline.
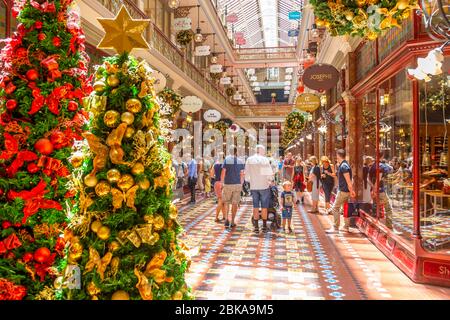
97, 5, 150, 54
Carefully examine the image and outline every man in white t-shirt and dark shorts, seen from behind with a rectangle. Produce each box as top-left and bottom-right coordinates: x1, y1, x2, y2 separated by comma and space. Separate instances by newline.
244, 144, 273, 232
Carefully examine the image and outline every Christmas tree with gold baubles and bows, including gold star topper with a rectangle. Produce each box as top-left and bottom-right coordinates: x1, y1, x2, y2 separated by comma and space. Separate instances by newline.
65, 7, 190, 300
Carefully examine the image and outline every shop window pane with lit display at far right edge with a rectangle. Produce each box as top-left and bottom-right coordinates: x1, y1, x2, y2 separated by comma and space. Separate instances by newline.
419, 57, 450, 253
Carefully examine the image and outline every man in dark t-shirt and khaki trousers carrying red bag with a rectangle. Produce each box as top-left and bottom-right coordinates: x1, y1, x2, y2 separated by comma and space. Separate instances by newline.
326, 149, 356, 233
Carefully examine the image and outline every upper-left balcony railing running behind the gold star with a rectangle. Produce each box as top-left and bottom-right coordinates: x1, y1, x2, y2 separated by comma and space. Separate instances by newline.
92, 0, 233, 110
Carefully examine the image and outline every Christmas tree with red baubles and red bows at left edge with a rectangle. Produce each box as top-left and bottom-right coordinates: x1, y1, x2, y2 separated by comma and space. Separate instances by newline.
0, 0, 90, 300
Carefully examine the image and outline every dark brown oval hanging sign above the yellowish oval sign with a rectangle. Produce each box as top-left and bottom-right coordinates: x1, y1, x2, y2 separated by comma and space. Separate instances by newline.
302, 63, 339, 91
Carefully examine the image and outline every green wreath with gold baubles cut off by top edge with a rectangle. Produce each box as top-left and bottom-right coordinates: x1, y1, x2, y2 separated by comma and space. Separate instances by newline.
310, 0, 419, 40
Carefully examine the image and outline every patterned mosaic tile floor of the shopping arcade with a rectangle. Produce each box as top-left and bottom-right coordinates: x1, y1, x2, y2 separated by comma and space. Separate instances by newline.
179, 195, 450, 300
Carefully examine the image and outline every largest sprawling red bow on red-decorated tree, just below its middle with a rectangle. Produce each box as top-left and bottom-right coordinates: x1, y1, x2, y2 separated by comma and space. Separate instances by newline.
8, 180, 63, 224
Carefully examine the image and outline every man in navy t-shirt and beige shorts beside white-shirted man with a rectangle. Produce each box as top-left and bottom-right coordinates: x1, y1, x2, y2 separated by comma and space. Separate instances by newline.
220, 146, 244, 228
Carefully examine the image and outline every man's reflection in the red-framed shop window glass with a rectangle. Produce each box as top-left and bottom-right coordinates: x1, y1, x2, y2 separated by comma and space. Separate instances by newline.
369, 153, 397, 233
